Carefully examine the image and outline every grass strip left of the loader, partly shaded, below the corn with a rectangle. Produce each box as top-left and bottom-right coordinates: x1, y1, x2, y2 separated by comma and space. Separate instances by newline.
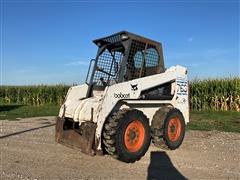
0, 104, 60, 120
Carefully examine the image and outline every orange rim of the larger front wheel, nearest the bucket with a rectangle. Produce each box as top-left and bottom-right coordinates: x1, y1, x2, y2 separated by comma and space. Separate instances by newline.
124, 120, 145, 152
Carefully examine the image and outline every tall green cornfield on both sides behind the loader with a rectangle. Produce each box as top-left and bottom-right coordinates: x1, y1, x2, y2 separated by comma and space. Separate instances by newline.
0, 78, 240, 112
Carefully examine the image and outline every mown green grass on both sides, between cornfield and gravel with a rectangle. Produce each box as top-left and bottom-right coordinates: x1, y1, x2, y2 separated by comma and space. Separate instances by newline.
0, 104, 240, 133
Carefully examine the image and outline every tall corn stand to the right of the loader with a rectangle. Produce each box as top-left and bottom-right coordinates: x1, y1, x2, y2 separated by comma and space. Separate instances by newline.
190, 78, 240, 112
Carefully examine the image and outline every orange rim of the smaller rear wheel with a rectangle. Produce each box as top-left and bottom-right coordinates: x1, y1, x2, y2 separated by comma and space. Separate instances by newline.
168, 117, 181, 142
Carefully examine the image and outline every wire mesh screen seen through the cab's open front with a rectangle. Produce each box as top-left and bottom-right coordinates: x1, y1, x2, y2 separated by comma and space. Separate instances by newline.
93, 49, 123, 86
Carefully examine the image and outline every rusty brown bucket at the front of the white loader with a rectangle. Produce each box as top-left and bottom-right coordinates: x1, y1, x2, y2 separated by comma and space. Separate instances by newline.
55, 117, 97, 155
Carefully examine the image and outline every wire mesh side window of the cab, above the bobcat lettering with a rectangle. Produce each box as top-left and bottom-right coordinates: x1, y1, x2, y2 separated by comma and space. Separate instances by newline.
126, 40, 159, 80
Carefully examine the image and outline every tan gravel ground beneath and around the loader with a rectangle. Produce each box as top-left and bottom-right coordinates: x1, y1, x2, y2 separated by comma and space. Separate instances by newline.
0, 117, 240, 180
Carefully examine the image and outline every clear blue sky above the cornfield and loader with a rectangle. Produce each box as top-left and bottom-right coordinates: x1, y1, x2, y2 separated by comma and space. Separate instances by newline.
0, 0, 240, 85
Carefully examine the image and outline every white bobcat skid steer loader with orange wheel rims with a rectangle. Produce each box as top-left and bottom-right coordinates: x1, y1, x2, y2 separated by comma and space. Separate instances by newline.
55, 31, 189, 162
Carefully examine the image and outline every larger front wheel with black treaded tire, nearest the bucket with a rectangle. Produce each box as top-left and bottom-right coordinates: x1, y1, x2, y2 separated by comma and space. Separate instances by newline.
103, 109, 151, 163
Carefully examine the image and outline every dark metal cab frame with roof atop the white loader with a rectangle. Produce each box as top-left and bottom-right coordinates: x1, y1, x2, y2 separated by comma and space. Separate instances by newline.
87, 31, 165, 89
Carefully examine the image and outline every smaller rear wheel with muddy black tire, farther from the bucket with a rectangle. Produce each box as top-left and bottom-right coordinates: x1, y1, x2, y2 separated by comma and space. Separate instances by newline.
151, 107, 185, 150
